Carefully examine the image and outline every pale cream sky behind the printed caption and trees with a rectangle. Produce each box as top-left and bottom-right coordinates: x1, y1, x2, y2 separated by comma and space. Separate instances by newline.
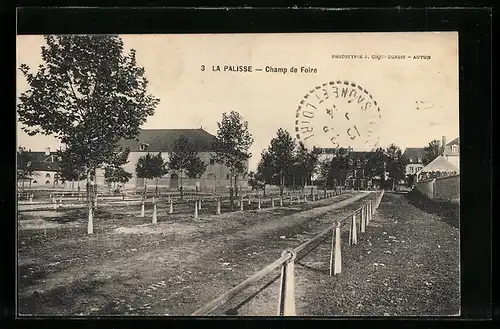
16, 32, 459, 170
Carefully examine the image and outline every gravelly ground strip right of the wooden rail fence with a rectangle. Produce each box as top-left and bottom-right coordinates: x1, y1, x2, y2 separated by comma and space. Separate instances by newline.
278, 193, 460, 316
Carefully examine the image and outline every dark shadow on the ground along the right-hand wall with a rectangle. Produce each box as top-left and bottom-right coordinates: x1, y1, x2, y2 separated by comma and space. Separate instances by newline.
406, 190, 460, 228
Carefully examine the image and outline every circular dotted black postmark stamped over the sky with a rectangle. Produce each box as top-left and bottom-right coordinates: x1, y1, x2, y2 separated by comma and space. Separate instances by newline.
295, 81, 382, 150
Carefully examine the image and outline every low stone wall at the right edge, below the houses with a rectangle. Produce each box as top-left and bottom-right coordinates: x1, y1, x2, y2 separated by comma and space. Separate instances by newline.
415, 175, 460, 202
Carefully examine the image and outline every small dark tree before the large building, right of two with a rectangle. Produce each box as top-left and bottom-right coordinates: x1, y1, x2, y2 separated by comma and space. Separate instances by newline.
169, 135, 207, 199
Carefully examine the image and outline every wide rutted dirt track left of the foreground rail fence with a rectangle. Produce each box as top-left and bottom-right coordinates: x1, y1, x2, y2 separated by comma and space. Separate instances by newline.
19, 194, 372, 315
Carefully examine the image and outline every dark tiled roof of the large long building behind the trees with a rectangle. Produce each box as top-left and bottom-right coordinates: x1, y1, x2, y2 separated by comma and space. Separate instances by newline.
120, 129, 219, 152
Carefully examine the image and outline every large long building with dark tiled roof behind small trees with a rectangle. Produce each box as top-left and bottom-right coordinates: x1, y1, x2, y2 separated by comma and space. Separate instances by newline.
120, 128, 248, 189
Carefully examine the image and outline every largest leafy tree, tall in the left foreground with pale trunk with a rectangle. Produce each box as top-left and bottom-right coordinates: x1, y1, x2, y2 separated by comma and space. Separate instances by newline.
17, 35, 159, 233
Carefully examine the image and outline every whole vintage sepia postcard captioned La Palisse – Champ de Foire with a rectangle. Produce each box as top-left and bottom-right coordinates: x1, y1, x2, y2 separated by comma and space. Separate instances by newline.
16, 32, 460, 316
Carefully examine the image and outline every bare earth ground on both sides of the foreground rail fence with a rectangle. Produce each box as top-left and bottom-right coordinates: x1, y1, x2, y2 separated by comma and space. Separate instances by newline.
18, 193, 460, 316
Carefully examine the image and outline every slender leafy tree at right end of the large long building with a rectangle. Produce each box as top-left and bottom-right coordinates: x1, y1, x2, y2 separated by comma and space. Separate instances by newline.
212, 111, 253, 208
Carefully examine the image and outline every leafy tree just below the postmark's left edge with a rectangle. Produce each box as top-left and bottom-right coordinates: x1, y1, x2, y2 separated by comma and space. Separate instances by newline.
262, 128, 296, 195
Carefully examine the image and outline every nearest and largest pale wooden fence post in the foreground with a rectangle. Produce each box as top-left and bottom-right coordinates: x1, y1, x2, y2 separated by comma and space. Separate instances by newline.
278, 249, 297, 316
